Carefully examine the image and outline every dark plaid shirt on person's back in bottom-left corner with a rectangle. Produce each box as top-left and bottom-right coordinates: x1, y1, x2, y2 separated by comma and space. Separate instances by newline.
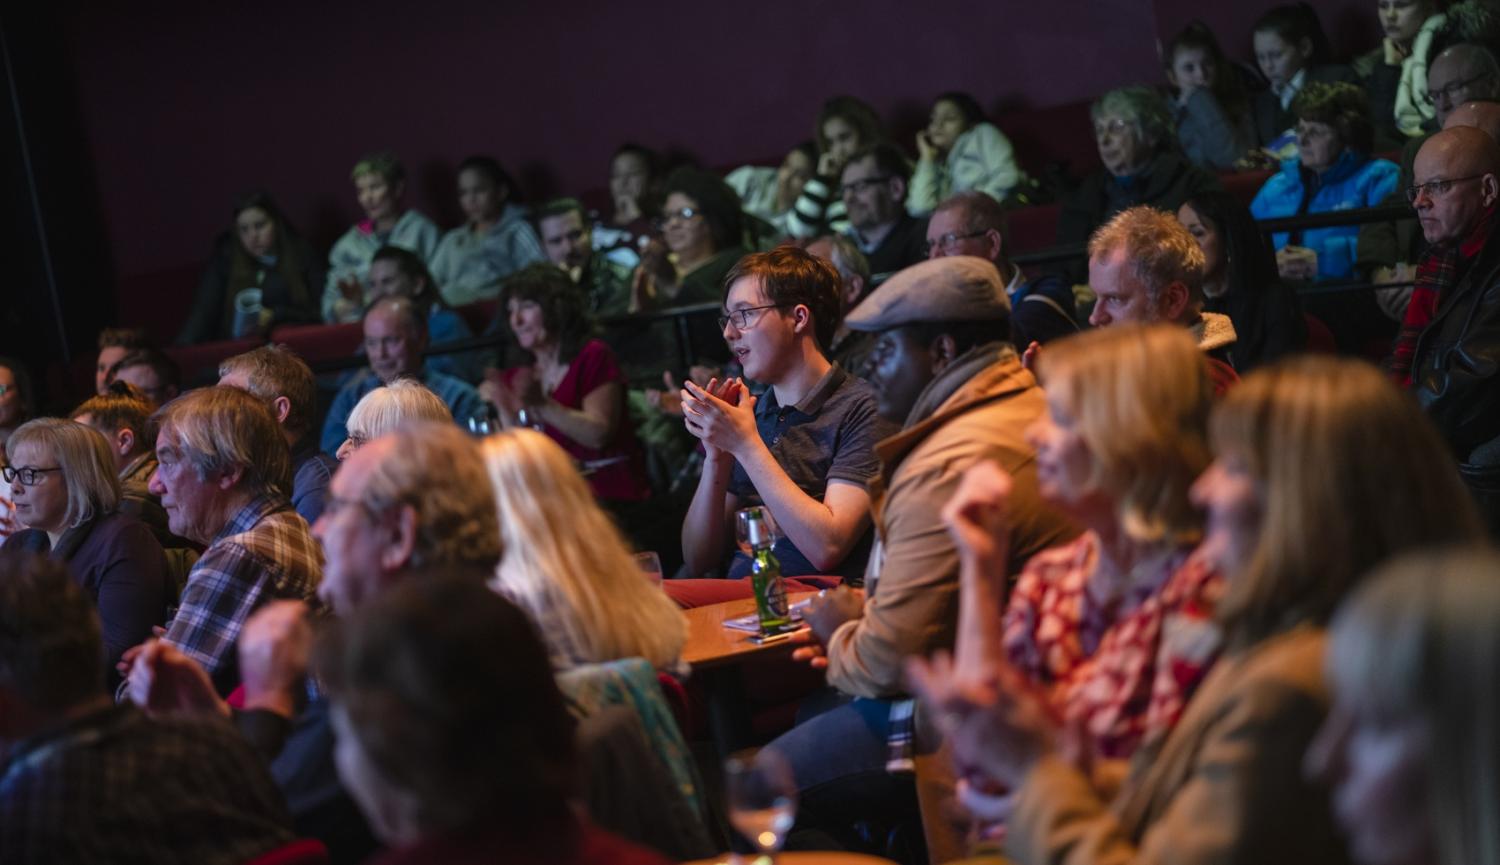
0, 705, 294, 865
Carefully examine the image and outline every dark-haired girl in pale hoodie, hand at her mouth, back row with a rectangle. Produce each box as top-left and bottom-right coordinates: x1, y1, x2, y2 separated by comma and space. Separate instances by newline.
906, 91, 1025, 216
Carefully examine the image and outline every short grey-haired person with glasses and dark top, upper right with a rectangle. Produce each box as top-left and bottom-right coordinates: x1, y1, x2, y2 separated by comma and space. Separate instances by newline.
1058, 87, 1220, 268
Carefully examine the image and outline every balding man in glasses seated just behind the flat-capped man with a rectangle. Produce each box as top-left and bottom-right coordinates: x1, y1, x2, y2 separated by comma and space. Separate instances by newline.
927, 192, 1079, 351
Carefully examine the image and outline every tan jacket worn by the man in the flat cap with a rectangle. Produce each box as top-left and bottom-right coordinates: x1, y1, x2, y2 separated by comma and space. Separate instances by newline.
828, 345, 1079, 697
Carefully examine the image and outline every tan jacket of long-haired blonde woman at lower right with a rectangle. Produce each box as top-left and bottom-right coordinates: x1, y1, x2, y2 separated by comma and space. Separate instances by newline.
1007, 627, 1349, 865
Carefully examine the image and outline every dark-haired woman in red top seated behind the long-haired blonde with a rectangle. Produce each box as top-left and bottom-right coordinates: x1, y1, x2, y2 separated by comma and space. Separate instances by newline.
480, 264, 651, 502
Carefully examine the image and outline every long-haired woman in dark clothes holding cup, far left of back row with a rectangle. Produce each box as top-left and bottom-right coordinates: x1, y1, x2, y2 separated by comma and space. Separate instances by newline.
177, 192, 324, 345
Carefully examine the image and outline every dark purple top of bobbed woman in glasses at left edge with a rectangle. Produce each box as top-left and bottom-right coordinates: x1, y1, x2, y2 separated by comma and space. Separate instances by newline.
0, 513, 174, 690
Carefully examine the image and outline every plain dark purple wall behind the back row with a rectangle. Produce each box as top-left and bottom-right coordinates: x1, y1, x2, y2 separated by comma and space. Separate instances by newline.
55, 0, 1374, 318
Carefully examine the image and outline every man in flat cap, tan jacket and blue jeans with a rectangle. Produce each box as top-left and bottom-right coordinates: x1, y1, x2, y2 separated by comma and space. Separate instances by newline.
771, 256, 1079, 837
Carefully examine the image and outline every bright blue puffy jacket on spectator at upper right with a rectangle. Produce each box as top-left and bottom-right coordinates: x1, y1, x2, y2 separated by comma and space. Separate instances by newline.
1250, 150, 1401, 279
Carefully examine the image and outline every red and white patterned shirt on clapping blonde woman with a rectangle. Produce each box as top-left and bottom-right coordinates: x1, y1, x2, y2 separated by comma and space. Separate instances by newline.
1004, 532, 1224, 759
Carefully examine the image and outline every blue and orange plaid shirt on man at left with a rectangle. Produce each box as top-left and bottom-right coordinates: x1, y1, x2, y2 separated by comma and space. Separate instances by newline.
164, 495, 323, 696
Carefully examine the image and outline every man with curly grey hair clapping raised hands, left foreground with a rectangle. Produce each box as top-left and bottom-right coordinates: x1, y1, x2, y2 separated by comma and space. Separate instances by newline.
129, 423, 501, 862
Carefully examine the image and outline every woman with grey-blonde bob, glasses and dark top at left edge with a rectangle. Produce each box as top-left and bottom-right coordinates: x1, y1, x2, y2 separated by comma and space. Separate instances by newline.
0, 418, 173, 688
